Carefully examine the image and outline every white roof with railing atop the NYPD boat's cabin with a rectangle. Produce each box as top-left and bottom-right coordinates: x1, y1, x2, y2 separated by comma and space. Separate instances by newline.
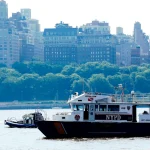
68, 92, 150, 106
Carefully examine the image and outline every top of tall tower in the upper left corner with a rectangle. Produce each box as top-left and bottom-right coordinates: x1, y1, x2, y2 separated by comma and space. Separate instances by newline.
0, 0, 8, 20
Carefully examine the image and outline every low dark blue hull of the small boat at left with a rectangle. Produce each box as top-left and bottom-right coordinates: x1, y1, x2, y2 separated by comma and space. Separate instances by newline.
5, 120, 37, 128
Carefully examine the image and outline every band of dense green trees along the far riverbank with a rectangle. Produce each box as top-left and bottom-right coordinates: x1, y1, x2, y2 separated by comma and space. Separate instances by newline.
0, 62, 150, 101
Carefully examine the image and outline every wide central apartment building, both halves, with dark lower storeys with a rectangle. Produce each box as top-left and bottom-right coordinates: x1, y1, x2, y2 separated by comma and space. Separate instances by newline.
43, 22, 116, 65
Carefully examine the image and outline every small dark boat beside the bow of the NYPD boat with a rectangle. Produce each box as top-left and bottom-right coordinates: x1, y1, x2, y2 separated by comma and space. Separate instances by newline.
4, 112, 44, 128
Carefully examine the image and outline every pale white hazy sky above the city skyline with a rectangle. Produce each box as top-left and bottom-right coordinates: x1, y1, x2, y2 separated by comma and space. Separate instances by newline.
6, 0, 150, 34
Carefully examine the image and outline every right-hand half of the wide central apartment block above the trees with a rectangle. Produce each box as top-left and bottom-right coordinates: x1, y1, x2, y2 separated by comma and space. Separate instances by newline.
77, 33, 116, 64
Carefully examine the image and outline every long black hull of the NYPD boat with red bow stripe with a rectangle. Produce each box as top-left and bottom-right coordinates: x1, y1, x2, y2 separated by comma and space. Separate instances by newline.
37, 121, 150, 138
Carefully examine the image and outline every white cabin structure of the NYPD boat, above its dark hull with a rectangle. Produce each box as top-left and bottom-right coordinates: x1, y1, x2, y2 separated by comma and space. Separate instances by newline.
52, 92, 150, 122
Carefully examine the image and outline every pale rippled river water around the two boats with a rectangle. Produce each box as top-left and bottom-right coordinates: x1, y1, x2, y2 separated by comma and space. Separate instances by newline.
0, 109, 150, 150
